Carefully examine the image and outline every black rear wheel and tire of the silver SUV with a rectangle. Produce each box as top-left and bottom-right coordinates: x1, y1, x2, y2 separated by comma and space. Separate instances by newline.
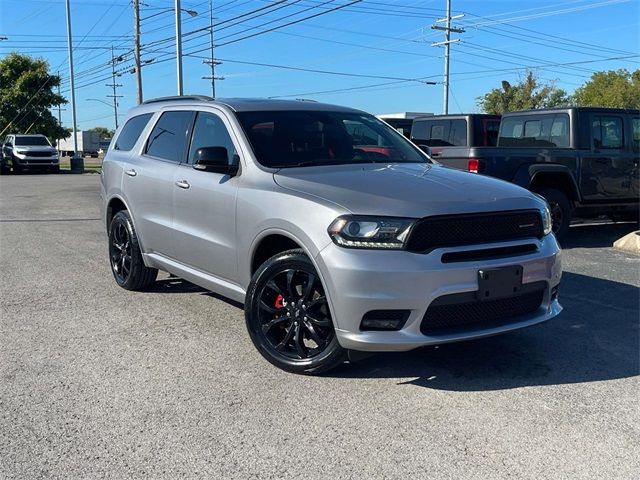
109, 210, 158, 290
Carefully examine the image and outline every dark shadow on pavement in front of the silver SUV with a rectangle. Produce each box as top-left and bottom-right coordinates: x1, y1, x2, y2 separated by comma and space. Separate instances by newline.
327, 272, 640, 391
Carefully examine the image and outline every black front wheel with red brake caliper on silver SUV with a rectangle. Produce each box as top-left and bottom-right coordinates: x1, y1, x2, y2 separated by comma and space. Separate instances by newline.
244, 250, 346, 375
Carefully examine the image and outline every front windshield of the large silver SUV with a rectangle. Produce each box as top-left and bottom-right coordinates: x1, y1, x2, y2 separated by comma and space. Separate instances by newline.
237, 110, 429, 168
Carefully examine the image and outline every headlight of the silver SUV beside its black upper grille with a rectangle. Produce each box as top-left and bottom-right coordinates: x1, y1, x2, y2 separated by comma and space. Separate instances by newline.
328, 215, 415, 250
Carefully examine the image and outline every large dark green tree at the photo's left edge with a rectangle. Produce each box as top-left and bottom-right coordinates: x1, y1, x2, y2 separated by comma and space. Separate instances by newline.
0, 53, 70, 140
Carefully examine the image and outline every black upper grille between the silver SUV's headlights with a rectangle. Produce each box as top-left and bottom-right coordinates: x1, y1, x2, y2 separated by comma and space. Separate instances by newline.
406, 210, 543, 252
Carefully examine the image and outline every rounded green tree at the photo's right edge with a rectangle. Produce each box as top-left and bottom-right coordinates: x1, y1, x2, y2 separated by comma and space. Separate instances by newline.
573, 69, 640, 108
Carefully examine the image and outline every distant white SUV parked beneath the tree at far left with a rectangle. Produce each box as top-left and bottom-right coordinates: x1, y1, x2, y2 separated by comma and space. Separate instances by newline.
0, 134, 60, 174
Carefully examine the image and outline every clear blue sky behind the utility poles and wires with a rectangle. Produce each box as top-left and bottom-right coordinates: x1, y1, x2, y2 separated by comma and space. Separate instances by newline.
0, 0, 640, 129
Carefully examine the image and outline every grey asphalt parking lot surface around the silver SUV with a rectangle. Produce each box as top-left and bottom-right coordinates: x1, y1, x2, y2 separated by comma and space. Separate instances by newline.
0, 174, 640, 479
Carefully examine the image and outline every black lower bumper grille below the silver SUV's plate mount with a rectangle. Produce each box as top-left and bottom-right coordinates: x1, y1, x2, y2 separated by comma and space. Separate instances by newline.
420, 288, 544, 335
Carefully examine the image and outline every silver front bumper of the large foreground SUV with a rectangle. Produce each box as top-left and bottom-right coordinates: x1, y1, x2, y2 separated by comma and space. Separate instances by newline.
315, 235, 562, 351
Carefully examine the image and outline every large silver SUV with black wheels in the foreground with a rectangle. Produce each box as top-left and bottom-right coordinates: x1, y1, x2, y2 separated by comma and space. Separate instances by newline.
102, 97, 561, 373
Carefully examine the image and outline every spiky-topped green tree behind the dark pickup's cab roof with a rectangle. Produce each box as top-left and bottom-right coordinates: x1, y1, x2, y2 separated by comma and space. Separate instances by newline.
477, 71, 569, 114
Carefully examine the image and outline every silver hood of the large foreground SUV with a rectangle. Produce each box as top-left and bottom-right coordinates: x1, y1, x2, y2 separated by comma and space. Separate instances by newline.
274, 163, 543, 218
